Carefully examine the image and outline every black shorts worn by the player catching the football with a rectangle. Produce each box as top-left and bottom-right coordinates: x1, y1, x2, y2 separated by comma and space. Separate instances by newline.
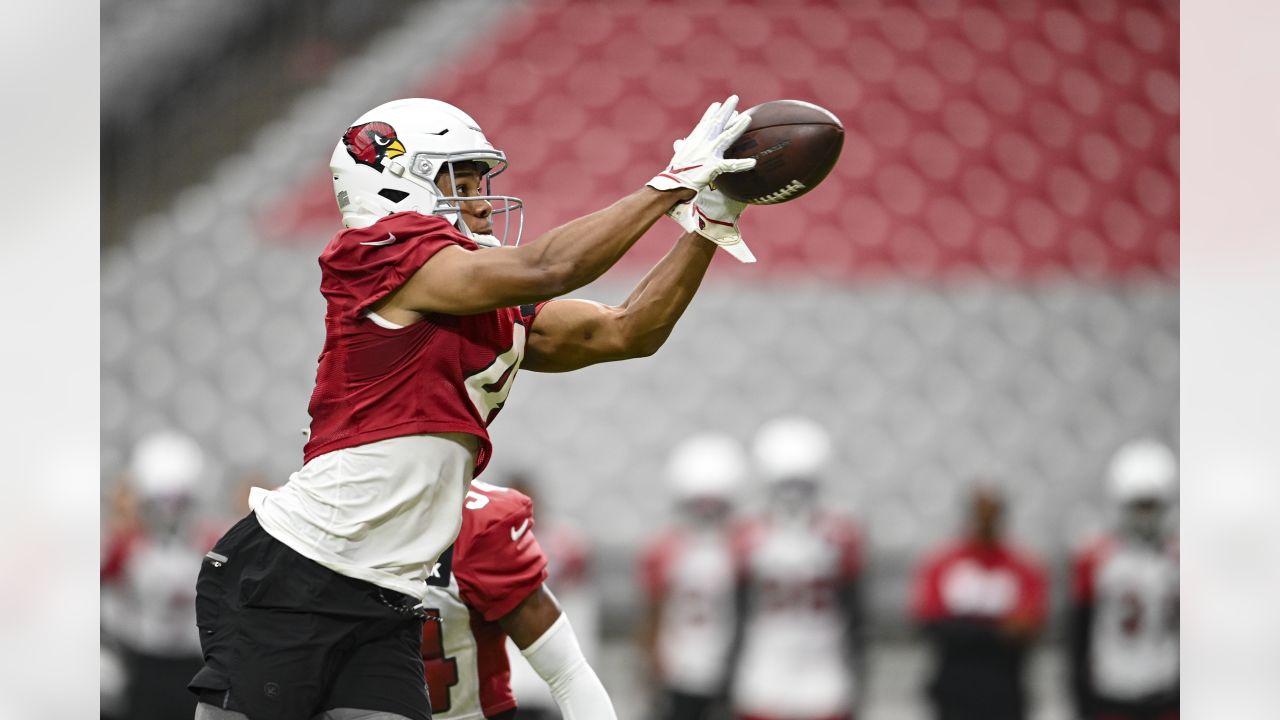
187, 512, 431, 720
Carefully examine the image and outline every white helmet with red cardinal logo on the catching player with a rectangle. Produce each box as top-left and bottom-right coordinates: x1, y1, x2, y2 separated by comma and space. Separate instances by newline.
329, 97, 525, 247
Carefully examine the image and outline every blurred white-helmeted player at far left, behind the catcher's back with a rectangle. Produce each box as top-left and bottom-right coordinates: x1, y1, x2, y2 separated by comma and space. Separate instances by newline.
100, 430, 216, 720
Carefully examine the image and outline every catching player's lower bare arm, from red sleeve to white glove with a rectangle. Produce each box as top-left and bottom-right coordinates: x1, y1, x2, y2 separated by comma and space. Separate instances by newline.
522, 233, 716, 373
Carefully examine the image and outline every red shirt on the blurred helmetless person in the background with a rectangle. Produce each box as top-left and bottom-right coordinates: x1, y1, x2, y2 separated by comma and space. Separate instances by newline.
913, 541, 1047, 625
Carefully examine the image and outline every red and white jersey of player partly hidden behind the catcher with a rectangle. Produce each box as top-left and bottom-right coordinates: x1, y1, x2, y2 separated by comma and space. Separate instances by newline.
422, 482, 547, 720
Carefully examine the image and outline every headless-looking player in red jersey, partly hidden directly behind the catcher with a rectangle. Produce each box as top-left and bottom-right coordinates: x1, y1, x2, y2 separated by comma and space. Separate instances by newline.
422, 480, 614, 720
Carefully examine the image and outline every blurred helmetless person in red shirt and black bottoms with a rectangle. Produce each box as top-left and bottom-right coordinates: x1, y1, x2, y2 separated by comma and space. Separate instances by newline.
913, 484, 1047, 720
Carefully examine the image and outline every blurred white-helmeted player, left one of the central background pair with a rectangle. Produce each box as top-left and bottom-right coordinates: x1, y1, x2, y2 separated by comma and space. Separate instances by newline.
641, 433, 748, 720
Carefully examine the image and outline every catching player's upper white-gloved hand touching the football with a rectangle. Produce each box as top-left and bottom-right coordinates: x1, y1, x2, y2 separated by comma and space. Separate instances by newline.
646, 95, 755, 192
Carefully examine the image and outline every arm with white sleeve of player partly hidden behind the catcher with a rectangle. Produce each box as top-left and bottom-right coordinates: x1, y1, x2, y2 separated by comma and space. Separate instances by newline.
499, 585, 617, 720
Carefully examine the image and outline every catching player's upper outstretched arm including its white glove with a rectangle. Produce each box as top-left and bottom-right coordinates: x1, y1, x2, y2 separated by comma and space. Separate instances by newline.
373, 96, 755, 315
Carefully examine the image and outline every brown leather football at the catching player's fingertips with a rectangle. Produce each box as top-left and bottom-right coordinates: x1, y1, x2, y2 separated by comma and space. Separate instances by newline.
716, 100, 845, 205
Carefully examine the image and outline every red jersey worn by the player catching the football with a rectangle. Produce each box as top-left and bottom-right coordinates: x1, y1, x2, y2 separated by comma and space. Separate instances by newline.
303, 213, 538, 475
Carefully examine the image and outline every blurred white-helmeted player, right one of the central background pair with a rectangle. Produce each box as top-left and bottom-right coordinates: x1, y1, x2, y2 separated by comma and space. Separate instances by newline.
730, 416, 867, 720
